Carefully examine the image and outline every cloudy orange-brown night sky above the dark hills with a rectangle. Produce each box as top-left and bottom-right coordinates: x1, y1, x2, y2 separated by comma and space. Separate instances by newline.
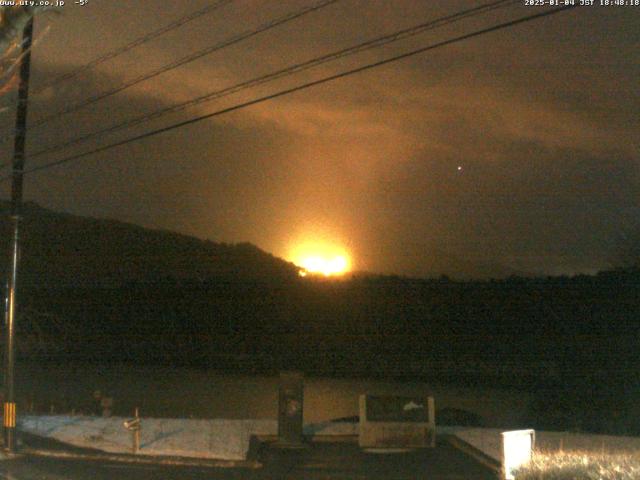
0, 0, 640, 277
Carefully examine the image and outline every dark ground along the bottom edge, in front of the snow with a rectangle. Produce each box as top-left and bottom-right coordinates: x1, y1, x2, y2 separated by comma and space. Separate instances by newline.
0, 443, 496, 480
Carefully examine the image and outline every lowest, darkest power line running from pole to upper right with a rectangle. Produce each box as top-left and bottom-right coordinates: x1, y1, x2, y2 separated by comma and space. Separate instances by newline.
0, 5, 576, 181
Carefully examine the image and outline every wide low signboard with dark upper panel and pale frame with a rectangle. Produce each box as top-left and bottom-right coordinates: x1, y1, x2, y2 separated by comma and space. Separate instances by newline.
359, 395, 436, 448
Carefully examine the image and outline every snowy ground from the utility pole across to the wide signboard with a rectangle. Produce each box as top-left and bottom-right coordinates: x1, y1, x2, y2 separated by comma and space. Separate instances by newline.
18, 415, 358, 460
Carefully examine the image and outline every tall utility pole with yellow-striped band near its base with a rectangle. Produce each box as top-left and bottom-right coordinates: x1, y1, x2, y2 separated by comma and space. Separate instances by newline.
3, 12, 33, 452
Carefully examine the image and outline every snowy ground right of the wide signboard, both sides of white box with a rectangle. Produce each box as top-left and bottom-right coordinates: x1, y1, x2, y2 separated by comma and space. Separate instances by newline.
438, 427, 640, 462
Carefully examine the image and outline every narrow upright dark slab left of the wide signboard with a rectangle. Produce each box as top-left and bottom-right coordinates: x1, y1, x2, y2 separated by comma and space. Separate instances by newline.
278, 372, 304, 447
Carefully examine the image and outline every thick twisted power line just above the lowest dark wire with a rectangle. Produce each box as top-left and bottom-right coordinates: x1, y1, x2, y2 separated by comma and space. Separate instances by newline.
23, 0, 517, 167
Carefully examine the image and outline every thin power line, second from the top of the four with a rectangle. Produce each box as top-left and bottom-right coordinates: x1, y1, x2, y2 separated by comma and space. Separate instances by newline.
20, 0, 338, 136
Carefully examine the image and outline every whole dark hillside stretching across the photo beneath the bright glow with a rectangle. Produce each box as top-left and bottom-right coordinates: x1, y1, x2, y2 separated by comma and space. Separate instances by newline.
0, 204, 640, 435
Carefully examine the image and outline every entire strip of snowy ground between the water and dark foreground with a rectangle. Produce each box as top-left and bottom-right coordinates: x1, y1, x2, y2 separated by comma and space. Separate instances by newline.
18, 415, 640, 462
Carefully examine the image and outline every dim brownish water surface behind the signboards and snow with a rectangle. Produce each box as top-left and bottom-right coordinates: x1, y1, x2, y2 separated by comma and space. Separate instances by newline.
16, 365, 529, 427
